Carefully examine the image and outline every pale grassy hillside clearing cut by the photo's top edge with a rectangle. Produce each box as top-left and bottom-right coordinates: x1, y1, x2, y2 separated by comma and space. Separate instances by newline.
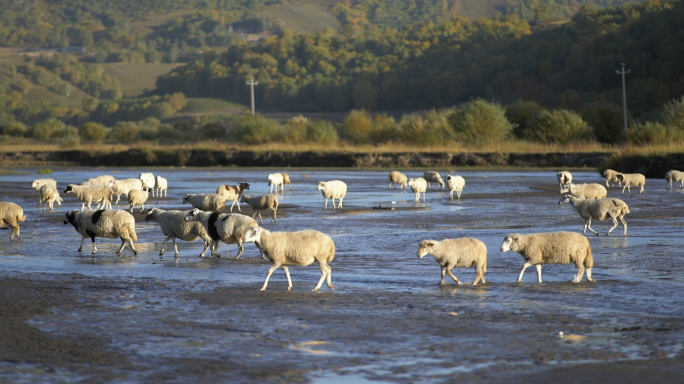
259, 0, 340, 33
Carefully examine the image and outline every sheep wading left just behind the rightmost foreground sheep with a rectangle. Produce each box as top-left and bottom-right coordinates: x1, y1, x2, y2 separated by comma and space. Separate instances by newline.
558, 195, 630, 236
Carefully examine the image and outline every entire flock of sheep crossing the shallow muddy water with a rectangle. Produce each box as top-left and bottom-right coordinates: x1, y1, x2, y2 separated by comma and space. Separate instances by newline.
0, 169, 684, 291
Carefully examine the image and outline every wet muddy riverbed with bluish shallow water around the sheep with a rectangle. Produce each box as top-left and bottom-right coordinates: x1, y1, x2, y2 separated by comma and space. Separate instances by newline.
0, 168, 684, 383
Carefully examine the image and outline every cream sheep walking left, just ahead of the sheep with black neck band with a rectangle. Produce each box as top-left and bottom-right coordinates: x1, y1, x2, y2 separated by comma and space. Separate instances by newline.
145, 208, 211, 258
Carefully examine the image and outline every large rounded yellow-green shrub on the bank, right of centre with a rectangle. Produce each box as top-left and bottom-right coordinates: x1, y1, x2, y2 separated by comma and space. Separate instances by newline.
448, 99, 513, 145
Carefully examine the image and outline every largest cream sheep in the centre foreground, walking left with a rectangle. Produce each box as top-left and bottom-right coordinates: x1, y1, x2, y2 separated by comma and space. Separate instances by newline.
243, 226, 335, 291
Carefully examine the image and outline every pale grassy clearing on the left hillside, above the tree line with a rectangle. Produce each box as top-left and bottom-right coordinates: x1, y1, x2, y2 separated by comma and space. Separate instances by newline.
102, 63, 183, 97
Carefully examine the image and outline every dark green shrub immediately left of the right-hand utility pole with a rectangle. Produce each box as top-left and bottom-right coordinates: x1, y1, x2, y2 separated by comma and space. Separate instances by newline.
581, 102, 631, 144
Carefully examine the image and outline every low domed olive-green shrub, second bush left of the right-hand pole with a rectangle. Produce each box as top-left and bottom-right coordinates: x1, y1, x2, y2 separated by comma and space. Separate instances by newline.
524, 109, 593, 144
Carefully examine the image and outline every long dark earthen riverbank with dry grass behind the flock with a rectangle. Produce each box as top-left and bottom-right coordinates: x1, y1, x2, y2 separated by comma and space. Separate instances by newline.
0, 149, 612, 168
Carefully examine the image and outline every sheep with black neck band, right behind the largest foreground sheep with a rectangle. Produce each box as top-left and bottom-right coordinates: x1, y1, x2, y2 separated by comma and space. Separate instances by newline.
183, 208, 265, 259
